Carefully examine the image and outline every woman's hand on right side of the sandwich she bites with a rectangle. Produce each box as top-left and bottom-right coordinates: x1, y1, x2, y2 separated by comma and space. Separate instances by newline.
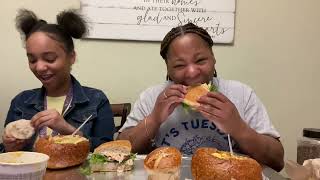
197, 92, 244, 135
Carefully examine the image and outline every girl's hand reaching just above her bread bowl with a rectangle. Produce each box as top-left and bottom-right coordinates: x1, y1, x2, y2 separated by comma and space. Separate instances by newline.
31, 109, 75, 134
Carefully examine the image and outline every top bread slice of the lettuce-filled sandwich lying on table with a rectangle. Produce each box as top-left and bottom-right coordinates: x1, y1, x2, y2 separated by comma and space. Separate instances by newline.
94, 140, 132, 153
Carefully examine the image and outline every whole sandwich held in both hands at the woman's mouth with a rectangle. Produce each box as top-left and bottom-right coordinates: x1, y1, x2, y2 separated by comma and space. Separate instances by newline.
183, 83, 217, 109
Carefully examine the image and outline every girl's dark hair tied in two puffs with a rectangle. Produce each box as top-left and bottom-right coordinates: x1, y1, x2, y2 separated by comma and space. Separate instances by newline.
16, 9, 88, 54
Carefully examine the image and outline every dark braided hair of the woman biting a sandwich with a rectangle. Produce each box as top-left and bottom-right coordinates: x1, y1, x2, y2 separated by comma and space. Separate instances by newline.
160, 23, 217, 80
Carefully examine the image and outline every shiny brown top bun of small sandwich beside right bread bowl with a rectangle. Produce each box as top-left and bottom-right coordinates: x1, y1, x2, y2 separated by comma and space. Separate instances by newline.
144, 147, 182, 173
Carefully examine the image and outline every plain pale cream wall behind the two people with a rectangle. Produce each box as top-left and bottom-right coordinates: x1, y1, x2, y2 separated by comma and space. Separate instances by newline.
0, 0, 320, 172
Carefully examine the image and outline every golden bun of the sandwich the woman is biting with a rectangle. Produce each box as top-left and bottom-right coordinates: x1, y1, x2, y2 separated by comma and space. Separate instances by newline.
183, 84, 209, 108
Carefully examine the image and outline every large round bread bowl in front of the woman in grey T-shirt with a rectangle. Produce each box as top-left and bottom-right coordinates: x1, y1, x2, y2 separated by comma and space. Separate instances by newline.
191, 148, 262, 180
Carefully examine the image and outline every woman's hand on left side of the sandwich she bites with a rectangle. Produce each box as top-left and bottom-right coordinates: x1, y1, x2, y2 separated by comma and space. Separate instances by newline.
151, 84, 187, 124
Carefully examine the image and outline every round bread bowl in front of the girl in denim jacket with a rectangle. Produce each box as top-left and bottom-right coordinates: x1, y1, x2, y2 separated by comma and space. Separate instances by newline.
35, 135, 90, 169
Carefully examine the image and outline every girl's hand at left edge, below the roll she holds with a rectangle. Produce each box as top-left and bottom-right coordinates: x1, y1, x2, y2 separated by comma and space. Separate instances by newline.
2, 131, 27, 152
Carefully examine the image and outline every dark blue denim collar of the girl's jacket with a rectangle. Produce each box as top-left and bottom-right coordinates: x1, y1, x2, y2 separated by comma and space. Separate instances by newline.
25, 75, 89, 111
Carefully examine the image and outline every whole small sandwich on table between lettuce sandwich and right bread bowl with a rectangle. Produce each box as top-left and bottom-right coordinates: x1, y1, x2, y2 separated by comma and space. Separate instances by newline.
144, 147, 182, 180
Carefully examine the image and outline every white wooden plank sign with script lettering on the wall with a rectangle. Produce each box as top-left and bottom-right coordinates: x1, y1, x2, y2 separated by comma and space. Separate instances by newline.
81, 0, 235, 43
